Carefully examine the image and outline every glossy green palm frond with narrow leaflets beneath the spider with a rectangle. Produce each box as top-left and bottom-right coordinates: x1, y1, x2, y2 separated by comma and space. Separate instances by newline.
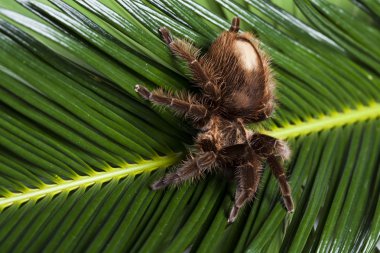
0, 0, 380, 252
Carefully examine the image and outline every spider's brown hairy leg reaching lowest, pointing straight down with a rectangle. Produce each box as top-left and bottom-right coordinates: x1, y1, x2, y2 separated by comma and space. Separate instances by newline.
228, 151, 262, 223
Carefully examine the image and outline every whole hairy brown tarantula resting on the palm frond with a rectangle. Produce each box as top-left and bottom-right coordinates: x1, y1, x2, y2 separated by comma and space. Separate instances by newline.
135, 17, 294, 223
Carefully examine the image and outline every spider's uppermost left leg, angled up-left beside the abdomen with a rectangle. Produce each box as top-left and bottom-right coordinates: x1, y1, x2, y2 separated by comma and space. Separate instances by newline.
159, 27, 221, 101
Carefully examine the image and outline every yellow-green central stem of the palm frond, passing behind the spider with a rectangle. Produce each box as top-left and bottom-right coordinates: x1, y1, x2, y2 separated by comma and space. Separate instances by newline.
0, 103, 380, 208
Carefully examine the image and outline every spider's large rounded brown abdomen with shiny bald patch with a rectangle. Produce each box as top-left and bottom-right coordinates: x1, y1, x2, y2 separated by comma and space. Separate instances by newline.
204, 32, 275, 123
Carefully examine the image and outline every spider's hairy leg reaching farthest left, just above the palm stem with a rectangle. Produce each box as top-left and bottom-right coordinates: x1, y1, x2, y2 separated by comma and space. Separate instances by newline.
135, 85, 208, 120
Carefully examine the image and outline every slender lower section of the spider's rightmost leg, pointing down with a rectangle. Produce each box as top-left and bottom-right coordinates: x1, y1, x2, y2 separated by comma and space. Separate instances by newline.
268, 156, 294, 213
